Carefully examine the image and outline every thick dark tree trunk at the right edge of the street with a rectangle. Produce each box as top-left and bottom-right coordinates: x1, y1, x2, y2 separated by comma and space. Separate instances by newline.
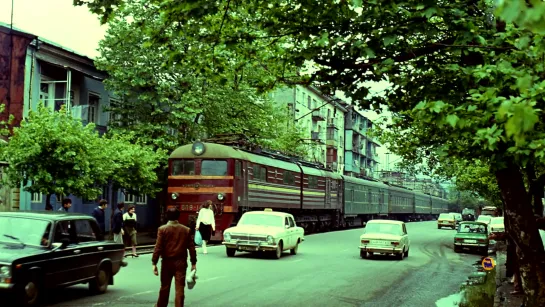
496, 163, 545, 307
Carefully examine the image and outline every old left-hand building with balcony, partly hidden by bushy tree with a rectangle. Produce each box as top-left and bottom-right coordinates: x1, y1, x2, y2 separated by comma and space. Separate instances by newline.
0, 25, 158, 229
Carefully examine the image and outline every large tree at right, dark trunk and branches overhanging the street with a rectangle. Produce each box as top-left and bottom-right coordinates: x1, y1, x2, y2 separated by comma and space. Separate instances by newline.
77, 0, 545, 306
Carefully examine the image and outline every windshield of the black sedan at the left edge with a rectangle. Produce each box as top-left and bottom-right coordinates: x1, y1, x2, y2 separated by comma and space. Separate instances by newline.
0, 216, 51, 246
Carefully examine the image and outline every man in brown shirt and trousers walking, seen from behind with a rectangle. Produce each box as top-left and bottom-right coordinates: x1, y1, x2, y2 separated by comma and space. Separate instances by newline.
151, 208, 197, 307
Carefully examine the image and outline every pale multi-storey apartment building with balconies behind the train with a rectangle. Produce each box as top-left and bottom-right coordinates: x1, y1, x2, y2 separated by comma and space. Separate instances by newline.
270, 86, 379, 177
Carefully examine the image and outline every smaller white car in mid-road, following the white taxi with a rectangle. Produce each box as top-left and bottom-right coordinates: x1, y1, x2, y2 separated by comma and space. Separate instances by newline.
359, 220, 411, 260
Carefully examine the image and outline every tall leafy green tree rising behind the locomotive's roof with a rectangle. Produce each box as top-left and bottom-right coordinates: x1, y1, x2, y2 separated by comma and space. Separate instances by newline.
96, 1, 304, 156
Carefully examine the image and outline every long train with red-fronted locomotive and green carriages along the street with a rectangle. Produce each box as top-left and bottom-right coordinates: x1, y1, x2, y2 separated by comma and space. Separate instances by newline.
165, 141, 449, 240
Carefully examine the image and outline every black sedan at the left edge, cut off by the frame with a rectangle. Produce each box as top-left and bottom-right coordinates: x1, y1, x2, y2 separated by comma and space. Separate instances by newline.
0, 211, 125, 306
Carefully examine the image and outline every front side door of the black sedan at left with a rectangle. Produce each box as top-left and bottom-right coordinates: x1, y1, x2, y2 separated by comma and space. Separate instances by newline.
46, 220, 84, 285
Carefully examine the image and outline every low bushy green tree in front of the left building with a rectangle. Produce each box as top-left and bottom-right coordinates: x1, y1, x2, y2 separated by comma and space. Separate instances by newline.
2, 104, 164, 207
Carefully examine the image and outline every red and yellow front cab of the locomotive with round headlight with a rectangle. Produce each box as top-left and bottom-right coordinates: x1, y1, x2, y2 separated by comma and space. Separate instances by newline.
167, 142, 241, 241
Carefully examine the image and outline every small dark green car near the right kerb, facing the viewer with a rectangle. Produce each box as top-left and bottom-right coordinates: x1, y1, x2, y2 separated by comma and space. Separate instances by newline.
454, 221, 489, 256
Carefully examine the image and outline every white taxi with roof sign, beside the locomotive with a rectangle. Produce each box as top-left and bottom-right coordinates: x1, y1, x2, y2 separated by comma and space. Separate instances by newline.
222, 209, 305, 259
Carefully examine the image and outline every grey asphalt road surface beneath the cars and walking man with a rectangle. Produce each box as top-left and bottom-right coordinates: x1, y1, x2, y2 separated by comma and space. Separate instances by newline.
46, 222, 480, 307
